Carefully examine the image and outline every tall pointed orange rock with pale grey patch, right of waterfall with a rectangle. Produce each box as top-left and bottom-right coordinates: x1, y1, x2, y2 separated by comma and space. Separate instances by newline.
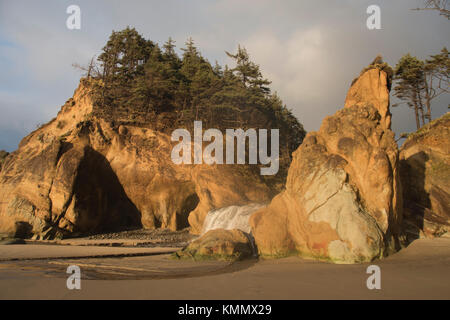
250, 63, 402, 263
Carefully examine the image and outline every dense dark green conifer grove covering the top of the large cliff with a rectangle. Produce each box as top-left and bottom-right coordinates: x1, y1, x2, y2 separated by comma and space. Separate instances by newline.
76, 27, 305, 180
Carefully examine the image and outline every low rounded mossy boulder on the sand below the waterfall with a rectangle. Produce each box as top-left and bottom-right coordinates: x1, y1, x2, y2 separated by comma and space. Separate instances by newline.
176, 229, 253, 260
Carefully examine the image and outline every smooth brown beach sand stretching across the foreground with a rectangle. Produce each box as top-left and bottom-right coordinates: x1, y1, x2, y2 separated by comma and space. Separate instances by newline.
0, 239, 450, 300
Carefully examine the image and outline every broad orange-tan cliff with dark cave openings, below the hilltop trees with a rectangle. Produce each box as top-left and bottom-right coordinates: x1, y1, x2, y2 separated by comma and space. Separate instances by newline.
0, 81, 273, 239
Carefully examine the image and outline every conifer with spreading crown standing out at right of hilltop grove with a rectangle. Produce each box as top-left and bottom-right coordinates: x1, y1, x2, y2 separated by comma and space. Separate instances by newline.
225, 45, 271, 94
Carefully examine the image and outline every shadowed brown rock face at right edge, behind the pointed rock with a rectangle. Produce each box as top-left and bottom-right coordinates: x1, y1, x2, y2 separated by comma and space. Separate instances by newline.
400, 113, 450, 238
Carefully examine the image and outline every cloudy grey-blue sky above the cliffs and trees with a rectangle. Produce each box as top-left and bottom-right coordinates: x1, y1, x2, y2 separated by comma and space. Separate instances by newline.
0, 0, 450, 151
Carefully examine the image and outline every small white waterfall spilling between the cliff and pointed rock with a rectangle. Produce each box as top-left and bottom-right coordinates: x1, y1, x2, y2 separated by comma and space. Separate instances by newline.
202, 203, 265, 235
